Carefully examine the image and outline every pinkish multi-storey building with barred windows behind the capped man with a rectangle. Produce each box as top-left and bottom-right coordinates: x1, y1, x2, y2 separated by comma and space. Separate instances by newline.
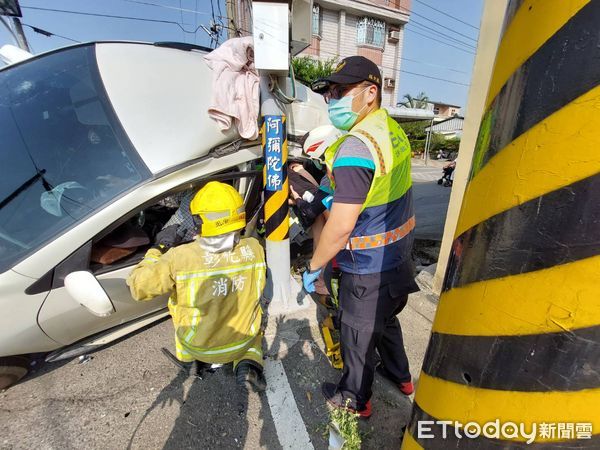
299, 0, 410, 107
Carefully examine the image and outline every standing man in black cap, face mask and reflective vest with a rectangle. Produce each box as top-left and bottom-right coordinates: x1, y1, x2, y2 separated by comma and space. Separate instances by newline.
303, 56, 418, 417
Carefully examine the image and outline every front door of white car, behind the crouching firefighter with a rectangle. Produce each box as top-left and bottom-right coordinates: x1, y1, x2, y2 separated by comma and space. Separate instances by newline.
38, 170, 261, 345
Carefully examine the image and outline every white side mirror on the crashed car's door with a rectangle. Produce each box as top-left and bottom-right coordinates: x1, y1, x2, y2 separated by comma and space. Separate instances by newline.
65, 271, 115, 317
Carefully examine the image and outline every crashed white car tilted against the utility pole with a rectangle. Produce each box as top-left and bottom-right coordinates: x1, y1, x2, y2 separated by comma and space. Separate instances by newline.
0, 42, 327, 388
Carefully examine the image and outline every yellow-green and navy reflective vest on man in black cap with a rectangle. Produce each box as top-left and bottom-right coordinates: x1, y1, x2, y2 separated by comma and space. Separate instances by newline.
325, 109, 414, 274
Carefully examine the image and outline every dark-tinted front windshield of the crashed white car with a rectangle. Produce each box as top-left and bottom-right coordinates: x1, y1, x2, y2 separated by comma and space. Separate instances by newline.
0, 46, 149, 272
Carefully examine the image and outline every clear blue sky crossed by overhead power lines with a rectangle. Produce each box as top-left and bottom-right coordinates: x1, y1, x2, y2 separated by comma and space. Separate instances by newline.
0, 0, 483, 108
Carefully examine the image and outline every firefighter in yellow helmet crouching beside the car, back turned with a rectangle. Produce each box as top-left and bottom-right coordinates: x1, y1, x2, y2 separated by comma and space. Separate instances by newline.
127, 182, 266, 391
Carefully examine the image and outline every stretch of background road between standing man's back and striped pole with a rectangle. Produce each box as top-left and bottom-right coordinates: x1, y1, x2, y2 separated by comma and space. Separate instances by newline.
412, 165, 451, 241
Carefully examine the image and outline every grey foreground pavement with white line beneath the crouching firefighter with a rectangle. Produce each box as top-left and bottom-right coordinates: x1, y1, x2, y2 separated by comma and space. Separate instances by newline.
0, 282, 431, 449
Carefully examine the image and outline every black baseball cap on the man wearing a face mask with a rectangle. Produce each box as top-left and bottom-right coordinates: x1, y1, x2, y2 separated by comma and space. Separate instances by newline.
311, 56, 381, 93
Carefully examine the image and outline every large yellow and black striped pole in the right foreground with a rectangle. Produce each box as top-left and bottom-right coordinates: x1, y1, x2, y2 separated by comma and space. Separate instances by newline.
402, 0, 600, 449
